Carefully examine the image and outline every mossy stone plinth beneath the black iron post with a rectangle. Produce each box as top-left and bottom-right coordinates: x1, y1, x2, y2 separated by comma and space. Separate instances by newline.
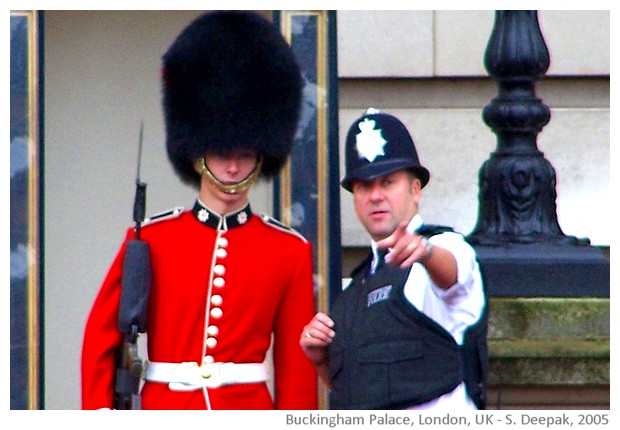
488, 298, 610, 409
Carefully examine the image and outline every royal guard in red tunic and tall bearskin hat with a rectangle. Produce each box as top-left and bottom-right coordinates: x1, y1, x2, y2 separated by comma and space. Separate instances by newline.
82, 11, 318, 410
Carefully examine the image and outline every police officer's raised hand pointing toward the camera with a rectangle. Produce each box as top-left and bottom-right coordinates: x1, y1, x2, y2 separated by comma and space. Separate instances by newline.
377, 223, 429, 268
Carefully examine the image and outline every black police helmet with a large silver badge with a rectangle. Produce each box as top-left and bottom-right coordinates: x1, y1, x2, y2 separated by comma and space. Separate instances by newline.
340, 108, 430, 191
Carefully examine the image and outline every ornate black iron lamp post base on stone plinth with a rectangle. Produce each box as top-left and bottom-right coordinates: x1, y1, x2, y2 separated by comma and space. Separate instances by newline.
468, 10, 609, 297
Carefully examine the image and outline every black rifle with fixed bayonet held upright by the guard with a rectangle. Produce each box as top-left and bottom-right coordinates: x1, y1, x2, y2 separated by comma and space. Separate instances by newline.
114, 123, 152, 409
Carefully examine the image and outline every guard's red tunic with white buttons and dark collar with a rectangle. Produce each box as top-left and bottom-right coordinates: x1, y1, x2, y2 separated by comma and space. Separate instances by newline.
82, 204, 318, 409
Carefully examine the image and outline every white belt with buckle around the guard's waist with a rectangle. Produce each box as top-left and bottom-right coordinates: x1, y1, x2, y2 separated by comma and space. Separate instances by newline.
144, 361, 269, 391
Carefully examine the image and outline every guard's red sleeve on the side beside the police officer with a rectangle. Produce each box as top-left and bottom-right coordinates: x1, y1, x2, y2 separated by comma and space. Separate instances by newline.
273, 242, 318, 410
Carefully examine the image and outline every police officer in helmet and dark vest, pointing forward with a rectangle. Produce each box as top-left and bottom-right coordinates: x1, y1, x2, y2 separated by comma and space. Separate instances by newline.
300, 108, 487, 410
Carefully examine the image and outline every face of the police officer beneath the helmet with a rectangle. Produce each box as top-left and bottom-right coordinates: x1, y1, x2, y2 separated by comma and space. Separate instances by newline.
351, 170, 422, 240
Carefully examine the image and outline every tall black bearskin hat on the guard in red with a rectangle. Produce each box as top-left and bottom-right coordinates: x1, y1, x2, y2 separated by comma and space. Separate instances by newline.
162, 11, 303, 186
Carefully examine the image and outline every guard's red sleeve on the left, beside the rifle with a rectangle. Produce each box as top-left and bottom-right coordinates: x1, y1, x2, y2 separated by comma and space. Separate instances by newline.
82, 232, 130, 409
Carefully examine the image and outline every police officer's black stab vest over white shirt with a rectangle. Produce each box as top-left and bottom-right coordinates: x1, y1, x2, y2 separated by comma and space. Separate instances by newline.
329, 227, 488, 409
